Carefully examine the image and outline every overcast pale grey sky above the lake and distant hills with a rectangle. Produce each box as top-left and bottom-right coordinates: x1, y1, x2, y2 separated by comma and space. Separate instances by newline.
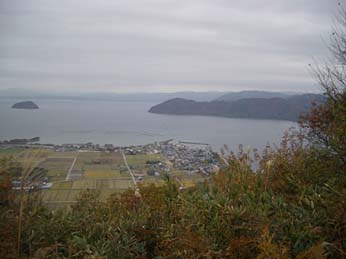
0, 0, 342, 92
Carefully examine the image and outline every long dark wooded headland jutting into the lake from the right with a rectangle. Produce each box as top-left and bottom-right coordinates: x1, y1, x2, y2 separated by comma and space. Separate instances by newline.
149, 94, 325, 121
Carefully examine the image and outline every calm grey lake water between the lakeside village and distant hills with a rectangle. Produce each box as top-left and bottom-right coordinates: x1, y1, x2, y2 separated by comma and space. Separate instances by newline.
0, 100, 296, 151
